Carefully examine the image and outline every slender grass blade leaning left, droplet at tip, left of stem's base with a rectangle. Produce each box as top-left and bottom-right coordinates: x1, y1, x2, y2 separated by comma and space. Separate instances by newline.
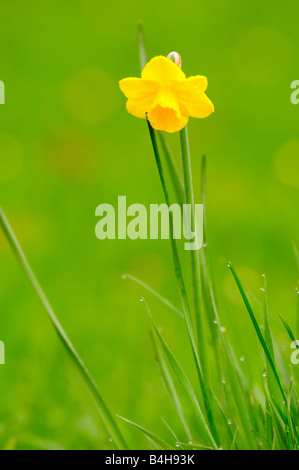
142, 299, 218, 449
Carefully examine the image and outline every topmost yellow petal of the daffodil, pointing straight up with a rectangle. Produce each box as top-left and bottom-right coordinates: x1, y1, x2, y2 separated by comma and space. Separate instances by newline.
141, 56, 186, 86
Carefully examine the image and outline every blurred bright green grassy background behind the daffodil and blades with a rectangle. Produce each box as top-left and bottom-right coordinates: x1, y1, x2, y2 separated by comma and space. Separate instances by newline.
0, 0, 299, 449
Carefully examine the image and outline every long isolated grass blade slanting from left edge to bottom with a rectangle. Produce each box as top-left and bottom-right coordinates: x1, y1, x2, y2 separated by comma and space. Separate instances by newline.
0, 208, 127, 449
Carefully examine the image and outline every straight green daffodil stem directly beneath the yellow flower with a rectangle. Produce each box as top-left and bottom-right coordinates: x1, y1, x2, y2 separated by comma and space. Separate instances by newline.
180, 126, 208, 380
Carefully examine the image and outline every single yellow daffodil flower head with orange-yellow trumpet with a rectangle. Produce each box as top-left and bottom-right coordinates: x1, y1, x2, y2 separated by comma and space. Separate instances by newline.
119, 56, 214, 132
